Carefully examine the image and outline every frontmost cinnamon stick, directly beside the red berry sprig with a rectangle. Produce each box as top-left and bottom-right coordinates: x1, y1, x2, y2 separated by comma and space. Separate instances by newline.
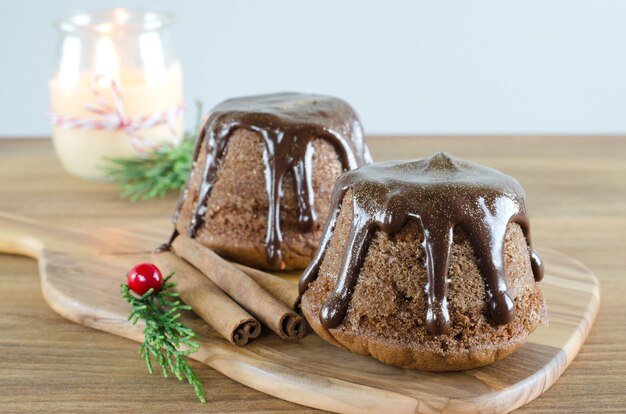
152, 251, 261, 346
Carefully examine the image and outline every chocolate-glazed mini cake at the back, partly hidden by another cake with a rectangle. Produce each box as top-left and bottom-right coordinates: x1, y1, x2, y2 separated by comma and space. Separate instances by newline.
174, 93, 371, 270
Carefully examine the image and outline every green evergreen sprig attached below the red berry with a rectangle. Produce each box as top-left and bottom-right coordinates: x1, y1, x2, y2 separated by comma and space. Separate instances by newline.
120, 272, 206, 403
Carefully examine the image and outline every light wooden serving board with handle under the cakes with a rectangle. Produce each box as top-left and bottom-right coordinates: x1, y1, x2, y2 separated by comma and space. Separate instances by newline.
0, 213, 600, 413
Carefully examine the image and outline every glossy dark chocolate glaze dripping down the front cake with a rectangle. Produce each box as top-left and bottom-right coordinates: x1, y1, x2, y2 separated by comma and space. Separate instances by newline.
300, 153, 543, 335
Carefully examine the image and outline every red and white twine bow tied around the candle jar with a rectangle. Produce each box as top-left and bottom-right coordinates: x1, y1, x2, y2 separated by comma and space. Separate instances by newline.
50, 75, 185, 157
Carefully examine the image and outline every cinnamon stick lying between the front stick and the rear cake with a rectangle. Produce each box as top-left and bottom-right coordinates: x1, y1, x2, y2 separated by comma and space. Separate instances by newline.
171, 235, 307, 341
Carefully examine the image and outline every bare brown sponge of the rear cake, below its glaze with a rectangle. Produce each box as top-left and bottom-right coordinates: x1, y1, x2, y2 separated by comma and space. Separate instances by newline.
176, 130, 342, 270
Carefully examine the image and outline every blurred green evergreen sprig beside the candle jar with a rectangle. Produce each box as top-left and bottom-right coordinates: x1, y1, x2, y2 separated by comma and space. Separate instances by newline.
102, 102, 202, 202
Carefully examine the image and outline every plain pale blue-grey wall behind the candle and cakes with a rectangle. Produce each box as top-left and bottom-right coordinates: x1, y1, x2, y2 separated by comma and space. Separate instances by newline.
0, 0, 626, 136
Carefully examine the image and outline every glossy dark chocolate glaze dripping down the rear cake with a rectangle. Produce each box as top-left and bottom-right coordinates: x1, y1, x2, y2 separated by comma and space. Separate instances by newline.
173, 93, 371, 268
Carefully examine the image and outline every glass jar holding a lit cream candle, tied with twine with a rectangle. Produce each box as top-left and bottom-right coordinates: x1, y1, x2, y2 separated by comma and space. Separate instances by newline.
50, 9, 184, 179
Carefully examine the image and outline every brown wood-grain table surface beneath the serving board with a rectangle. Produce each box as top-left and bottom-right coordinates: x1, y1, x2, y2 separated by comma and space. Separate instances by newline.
0, 136, 626, 413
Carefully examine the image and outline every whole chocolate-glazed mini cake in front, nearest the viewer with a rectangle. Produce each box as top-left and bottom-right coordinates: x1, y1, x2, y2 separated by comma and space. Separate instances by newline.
300, 153, 545, 371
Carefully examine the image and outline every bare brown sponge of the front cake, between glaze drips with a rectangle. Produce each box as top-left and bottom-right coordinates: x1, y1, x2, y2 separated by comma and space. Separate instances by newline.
301, 192, 546, 371
